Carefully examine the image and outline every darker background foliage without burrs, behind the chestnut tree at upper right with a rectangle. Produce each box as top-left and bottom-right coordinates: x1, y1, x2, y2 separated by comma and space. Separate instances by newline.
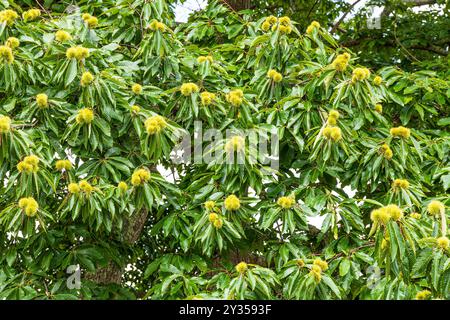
216, 0, 450, 72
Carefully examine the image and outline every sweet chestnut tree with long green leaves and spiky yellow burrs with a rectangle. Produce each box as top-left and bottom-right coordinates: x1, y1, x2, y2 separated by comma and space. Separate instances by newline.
0, 0, 450, 299
